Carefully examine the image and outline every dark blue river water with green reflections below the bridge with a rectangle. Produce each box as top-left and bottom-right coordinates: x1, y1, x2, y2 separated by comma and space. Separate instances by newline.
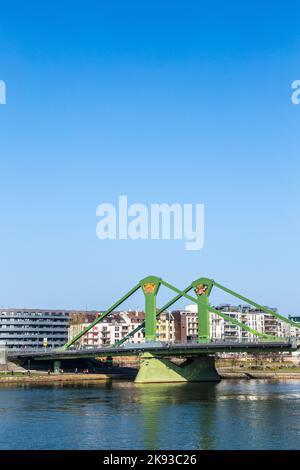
0, 380, 300, 450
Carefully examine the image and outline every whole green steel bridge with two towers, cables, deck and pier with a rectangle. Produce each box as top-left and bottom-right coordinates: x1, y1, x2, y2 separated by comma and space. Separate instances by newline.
10, 276, 300, 383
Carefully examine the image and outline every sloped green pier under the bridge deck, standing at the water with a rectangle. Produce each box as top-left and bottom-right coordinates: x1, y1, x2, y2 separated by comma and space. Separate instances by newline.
135, 353, 220, 383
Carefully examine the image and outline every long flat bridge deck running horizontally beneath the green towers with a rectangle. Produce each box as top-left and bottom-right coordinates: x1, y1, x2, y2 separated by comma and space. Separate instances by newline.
8, 341, 298, 361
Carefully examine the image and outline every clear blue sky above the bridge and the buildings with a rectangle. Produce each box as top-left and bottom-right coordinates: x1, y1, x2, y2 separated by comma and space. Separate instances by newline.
0, 0, 300, 314
